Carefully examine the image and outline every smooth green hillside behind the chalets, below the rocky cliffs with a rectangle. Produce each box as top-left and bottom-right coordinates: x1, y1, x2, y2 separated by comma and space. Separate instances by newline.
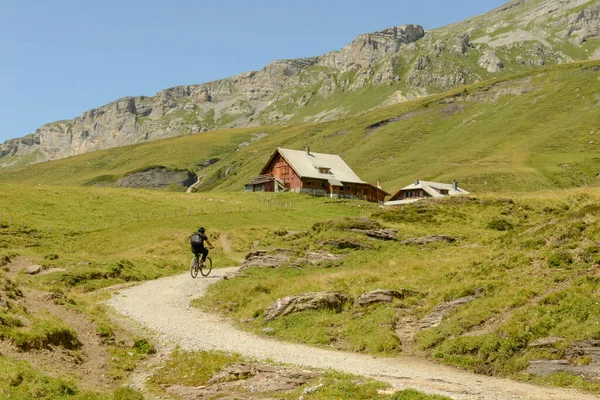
0, 62, 600, 192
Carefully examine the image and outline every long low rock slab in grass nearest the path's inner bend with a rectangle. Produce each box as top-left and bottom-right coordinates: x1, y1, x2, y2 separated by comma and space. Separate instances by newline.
264, 292, 350, 321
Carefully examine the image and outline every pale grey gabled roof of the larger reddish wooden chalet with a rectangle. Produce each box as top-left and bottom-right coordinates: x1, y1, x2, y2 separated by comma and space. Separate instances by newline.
275, 147, 368, 185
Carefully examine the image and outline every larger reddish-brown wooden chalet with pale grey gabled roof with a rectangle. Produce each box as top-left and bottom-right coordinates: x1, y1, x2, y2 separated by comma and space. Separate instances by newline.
246, 147, 389, 202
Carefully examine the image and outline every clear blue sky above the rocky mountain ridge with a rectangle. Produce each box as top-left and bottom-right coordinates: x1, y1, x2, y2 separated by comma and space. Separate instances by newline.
0, 0, 508, 143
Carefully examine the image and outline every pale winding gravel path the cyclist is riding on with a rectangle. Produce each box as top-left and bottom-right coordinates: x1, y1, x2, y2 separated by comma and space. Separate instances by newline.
108, 268, 600, 400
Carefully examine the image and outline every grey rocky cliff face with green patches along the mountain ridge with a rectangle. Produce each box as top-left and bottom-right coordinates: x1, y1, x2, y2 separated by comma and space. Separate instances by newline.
0, 0, 600, 168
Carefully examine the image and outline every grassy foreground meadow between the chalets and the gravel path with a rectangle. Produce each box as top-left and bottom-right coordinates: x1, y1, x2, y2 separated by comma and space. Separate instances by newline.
0, 184, 600, 392
